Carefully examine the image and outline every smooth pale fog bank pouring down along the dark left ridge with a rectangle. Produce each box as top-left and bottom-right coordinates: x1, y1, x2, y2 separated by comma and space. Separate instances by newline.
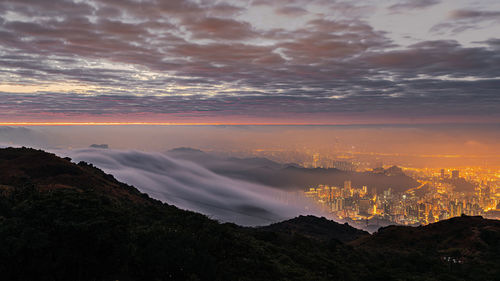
52, 148, 311, 226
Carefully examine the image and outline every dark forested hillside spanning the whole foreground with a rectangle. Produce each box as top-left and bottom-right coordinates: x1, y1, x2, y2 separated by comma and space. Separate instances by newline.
0, 148, 500, 280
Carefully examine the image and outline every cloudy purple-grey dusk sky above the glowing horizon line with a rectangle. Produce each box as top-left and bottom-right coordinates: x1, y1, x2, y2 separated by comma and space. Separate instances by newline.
0, 0, 500, 124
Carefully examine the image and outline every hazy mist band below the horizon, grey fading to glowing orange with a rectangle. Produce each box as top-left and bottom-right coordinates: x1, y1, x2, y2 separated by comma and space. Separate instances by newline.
0, 124, 500, 168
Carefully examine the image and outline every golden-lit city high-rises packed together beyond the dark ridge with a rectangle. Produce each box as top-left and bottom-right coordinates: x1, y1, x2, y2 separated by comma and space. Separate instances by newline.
305, 167, 500, 225
